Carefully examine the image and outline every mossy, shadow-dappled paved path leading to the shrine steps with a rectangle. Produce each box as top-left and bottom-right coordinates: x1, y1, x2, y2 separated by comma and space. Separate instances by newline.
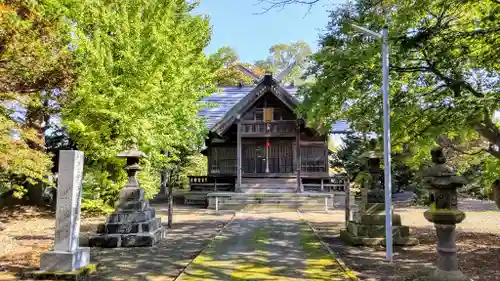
177, 210, 349, 281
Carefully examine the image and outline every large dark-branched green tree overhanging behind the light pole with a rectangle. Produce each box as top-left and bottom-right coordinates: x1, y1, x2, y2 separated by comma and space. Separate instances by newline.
301, 0, 500, 196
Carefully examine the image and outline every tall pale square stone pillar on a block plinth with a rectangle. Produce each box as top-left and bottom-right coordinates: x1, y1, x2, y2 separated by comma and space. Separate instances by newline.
40, 150, 90, 272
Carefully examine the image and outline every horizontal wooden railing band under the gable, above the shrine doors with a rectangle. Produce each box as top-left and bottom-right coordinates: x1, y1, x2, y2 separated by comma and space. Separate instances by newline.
241, 120, 296, 136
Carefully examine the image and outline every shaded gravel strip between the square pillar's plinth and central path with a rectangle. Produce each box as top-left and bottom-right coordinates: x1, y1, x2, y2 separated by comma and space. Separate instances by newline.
91, 209, 233, 281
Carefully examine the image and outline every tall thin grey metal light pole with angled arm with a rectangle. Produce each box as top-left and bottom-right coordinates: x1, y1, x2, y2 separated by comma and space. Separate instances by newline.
351, 21, 392, 262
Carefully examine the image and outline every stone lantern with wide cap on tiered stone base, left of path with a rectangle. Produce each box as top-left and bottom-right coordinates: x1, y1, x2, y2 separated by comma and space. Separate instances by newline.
89, 145, 165, 248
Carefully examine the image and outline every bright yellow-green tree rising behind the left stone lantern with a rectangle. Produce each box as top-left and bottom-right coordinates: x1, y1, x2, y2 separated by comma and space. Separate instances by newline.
63, 0, 213, 208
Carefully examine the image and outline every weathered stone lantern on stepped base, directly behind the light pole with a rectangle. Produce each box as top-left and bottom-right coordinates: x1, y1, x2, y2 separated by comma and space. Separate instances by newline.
340, 140, 418, 246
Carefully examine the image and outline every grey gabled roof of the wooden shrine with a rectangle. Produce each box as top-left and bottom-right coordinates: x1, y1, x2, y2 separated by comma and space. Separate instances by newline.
198, 75, 350, 134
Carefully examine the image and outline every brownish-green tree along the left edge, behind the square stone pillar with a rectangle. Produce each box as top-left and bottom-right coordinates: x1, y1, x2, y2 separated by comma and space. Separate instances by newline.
0, 0, 74, 198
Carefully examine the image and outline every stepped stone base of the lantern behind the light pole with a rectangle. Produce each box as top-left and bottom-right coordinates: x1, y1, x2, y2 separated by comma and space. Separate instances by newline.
340, 203, 419, 246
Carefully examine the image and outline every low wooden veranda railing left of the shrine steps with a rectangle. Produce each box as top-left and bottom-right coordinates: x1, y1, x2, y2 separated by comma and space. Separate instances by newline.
188, 176, 236, 192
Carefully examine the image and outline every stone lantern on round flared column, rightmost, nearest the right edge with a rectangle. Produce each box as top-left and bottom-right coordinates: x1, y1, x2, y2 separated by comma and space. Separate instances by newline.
418, 148, 470, 281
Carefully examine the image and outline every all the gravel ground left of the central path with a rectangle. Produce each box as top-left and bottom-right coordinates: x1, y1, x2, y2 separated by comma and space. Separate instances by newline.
0, 205, 234, 281
